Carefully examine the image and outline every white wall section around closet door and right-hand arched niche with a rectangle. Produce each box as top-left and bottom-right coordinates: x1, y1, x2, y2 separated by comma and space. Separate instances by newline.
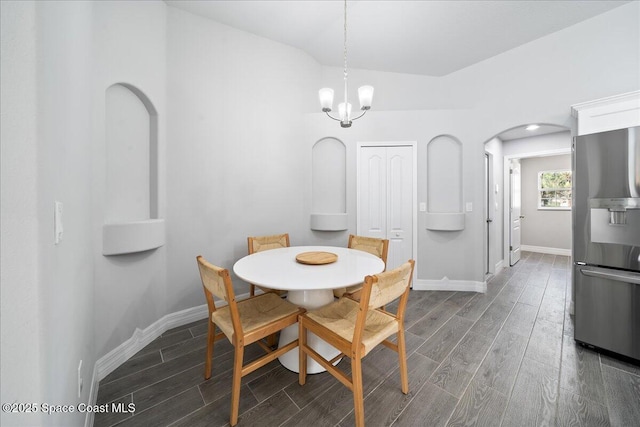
305, 110, 484, 280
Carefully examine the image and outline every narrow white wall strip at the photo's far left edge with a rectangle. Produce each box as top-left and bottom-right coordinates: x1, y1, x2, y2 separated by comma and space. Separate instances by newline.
0, 1, 43, 426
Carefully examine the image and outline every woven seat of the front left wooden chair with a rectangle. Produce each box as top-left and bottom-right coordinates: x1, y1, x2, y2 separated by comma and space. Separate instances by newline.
211, 292, 299, 341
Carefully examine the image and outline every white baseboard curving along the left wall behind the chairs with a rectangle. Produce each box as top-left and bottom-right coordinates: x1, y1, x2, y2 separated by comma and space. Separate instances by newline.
84, 293, 249, 427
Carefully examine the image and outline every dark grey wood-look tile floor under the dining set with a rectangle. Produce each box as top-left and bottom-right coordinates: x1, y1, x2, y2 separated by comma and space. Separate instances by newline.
94, 253, 640, 427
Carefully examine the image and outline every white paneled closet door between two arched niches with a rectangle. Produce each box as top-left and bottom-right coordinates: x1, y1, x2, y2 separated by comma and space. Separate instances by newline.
357, 145, 414, 270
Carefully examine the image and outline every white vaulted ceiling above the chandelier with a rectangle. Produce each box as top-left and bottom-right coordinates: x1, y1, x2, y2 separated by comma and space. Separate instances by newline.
165, 0, 629, 76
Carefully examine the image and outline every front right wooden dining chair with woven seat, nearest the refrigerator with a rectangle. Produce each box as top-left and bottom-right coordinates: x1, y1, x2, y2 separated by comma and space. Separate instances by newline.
298, 260, 415, 427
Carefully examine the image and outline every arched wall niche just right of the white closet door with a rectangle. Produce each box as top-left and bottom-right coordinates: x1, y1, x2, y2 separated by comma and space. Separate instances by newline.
426, 135, 464, 231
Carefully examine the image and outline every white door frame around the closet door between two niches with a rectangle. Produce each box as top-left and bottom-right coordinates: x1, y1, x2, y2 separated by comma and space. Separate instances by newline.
356, 141, 419, 283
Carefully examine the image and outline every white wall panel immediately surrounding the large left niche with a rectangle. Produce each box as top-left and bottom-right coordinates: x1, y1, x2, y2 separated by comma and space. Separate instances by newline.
89, 1, 169, 357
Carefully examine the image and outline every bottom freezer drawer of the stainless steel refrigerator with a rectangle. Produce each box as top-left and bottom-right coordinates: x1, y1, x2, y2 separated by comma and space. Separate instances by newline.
574, 265, 640, 360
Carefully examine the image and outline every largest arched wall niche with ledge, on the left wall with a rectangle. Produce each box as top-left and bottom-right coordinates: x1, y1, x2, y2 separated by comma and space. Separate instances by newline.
103, 83, 165, 255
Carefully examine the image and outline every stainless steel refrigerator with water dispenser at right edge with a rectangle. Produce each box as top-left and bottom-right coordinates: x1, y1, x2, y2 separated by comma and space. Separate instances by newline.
572, 127, 640, 361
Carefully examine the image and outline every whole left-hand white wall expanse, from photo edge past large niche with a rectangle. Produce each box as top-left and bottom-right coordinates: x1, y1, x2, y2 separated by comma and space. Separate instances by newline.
2, 2, 166, 425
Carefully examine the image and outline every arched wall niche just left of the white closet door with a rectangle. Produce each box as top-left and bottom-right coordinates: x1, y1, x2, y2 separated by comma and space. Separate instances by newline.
311, 137, 348, 231
